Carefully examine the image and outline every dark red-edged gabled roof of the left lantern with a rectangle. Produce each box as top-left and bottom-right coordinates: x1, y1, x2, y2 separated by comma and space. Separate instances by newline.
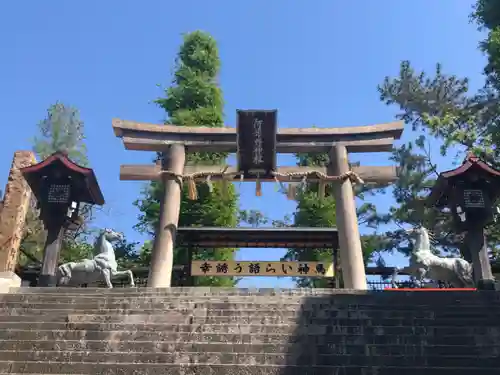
21, 151, 104, 206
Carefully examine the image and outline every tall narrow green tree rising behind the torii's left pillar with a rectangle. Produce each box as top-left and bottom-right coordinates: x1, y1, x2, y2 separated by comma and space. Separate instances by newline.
135, 31, 238, 286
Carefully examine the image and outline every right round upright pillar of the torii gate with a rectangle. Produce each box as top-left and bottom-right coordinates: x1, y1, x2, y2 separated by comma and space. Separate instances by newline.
329, 144, 367, 290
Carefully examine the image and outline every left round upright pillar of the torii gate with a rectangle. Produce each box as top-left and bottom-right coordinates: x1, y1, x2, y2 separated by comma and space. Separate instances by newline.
148, 144, 186, 288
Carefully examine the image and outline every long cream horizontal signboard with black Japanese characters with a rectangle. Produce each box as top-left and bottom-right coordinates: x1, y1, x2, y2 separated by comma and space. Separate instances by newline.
191, 260, 334, 277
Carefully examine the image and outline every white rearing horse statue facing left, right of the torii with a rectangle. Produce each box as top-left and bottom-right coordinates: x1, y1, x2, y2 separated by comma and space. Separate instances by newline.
392, 227, 474, 288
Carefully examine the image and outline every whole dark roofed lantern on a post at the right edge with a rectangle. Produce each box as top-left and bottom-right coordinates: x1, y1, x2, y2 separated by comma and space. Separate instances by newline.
427, 153, 500, 289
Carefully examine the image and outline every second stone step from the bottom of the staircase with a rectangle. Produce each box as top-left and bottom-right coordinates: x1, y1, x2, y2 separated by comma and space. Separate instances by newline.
0, 348, 499, 368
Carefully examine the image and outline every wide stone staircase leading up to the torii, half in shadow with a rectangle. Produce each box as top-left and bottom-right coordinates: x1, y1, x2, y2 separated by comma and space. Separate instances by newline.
0, 288, 500, 375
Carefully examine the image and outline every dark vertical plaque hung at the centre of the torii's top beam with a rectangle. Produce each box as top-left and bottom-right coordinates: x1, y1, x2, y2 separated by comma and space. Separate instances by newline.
236, 110, 278, 178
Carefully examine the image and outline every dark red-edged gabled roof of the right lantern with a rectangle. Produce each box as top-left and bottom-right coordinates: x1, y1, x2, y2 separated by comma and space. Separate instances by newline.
426, 152, 500, 207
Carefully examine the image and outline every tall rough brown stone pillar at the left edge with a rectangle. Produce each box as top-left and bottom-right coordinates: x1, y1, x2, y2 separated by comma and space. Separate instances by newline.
0, 151, 36, 272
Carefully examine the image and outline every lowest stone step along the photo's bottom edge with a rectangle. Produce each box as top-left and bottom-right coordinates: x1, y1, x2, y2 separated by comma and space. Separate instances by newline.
0, 360, 498, 375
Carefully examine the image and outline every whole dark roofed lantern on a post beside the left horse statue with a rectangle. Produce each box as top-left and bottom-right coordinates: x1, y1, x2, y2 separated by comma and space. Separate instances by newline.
21, 152, 104, 286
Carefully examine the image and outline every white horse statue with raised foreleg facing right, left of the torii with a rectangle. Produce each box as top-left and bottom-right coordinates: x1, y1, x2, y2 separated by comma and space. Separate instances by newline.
57, 228, 135, 288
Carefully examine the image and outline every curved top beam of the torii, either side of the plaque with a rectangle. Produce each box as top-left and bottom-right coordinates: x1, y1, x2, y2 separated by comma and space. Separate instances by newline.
113, 119, 404, 153
